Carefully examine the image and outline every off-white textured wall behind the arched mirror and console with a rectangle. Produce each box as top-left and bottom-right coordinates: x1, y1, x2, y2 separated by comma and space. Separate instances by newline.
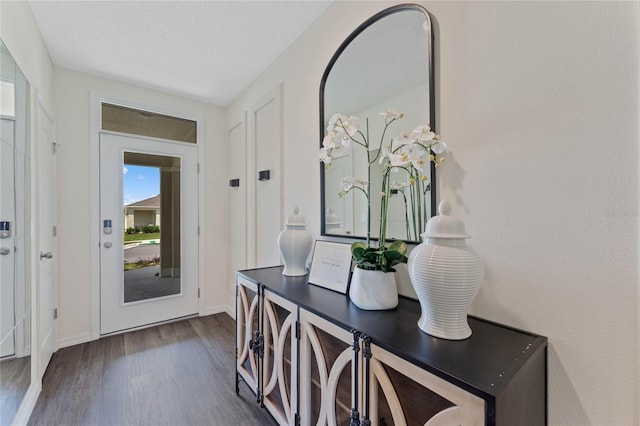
227, 2, 640, 425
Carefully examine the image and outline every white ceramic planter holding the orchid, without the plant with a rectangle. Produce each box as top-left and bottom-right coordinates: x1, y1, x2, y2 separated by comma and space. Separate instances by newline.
349, 268, 398, 311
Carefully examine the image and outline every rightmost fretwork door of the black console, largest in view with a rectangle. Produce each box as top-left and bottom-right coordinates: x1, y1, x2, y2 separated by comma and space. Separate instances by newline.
365, 344, 485, 426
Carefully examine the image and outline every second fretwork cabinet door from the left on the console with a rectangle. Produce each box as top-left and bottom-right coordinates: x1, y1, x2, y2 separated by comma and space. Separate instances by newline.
262, 290, 298, 425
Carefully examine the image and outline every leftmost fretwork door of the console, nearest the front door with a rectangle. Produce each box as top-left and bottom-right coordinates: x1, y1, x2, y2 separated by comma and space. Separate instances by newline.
236, 277, 262, 394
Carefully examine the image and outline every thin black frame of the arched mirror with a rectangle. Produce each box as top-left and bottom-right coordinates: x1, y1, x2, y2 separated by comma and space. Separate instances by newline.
320, 3, 437, 244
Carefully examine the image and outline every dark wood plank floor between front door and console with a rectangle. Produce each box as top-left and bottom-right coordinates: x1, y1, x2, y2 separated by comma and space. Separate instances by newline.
29, 314, 275, 426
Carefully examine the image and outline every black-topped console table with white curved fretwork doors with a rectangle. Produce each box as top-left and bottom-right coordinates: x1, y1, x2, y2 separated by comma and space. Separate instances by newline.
236, 266, 547, 426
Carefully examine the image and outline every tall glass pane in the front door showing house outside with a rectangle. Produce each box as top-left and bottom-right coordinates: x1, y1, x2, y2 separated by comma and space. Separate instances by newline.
122, 151, 181, 303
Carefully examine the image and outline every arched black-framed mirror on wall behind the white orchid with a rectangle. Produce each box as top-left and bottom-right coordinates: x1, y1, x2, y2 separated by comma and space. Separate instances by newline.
320, 4, 436, 242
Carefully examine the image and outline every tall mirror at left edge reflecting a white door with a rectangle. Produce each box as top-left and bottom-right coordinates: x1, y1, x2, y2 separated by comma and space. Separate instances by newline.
0, 40, 31, 425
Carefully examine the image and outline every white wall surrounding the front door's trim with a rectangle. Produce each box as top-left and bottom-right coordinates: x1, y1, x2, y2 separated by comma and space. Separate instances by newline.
54, 68, 227, 346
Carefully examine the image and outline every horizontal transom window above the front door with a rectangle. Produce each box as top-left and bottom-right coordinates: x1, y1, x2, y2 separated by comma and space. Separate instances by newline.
102, 104, 197, 143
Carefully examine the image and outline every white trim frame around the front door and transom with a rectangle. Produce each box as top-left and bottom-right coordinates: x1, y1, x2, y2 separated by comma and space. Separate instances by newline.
89, 90, 206, 344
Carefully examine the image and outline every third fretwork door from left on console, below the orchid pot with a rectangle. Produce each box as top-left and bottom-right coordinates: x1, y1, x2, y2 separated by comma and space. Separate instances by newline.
300, 309, 360, 426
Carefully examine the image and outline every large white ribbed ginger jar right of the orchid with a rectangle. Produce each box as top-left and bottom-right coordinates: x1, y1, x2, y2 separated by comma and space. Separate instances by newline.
407, 200, 484, 340
